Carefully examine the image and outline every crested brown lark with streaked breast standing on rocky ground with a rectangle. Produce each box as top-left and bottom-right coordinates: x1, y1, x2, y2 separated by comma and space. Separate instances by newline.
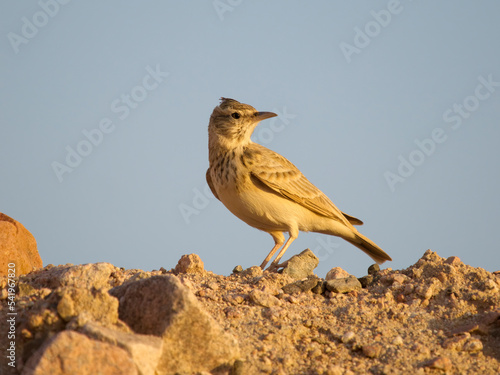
206, 97, 392, 271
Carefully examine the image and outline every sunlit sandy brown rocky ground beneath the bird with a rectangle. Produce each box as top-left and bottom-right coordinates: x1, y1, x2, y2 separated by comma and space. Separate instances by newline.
0, 250, 500, 375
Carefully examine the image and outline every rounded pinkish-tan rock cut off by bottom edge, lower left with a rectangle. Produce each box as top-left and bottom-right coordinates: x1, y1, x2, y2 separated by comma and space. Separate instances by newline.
22, 331, 138, 375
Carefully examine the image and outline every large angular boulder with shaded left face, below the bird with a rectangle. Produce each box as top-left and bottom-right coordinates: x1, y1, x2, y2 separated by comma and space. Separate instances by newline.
110, 275, 239, 374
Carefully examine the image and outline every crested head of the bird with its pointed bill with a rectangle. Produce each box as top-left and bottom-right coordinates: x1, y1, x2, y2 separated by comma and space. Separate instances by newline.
208, 98, 277, 148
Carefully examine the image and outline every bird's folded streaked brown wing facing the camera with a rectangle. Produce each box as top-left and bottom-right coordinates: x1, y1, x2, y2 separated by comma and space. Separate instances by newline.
245, 144, 362, 225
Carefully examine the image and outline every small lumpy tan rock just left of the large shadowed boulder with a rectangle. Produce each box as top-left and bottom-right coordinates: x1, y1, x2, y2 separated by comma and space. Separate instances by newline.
57, 287, 118, 324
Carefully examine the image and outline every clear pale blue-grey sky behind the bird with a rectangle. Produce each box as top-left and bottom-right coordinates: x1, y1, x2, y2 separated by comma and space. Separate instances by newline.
0, 0, 500, 277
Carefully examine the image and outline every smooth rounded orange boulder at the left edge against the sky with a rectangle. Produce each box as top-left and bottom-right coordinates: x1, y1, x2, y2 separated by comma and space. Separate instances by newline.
0, 212, 43, 277
